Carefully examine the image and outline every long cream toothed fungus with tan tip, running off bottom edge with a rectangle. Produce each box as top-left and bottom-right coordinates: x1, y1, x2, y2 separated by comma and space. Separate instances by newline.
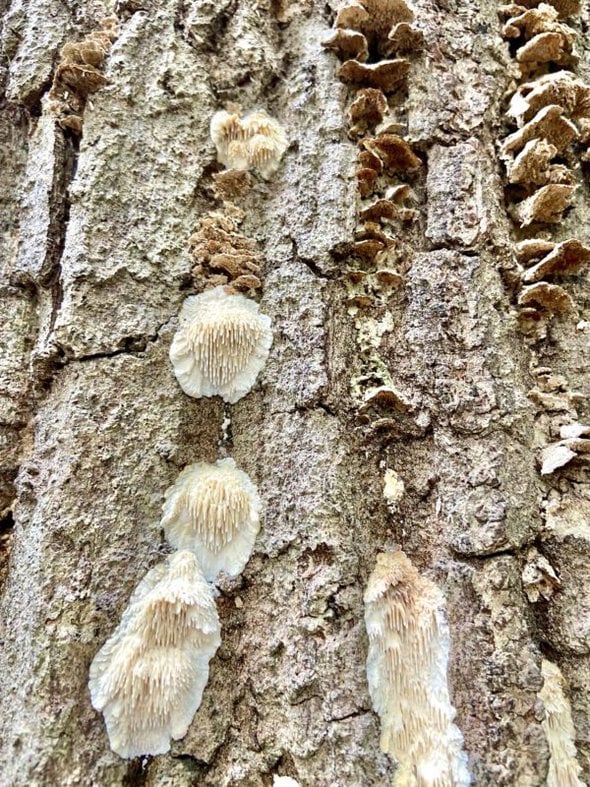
364, 551, 470, 787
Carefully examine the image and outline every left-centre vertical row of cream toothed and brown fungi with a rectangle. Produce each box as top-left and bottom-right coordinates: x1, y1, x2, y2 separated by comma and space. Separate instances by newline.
89, 107, 287, 757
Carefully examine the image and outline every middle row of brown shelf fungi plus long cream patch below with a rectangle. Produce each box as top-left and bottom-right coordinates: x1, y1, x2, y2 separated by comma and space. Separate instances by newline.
324, 0, 469, 785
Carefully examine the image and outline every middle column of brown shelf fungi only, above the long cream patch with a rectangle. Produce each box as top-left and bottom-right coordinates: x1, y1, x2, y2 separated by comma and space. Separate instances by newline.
323, 0, 424, 425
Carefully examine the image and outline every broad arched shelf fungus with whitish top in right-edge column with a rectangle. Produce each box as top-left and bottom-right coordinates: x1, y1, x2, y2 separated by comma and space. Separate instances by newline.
508, 71, 590, 124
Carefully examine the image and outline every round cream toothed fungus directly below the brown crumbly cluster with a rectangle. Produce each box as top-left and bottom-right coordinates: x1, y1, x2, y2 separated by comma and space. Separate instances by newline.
170, 287, 272, 404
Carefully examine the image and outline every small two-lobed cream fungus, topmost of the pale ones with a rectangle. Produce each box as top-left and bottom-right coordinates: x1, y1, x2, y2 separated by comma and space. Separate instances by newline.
210, 105, 289, 180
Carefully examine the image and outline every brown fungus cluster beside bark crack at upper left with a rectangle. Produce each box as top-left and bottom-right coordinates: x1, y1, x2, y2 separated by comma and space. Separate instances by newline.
49, 16, 119, 134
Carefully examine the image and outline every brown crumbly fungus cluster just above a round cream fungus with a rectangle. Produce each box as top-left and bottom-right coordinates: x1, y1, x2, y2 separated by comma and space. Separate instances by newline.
189, 211, 262, 287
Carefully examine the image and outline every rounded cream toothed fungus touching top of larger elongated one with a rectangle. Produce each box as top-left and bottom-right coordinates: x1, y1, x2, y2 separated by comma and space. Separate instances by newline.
161, 459, 261, 582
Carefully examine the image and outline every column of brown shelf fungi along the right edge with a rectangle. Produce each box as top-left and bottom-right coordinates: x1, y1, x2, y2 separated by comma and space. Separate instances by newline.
500, 0, 590, 475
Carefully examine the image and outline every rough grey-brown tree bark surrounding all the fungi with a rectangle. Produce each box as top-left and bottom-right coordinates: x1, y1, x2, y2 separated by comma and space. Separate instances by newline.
0, 0, 590, 787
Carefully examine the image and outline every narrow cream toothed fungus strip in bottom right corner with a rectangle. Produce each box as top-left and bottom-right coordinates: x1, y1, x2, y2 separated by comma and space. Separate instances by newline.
538, 659, 584, 787
